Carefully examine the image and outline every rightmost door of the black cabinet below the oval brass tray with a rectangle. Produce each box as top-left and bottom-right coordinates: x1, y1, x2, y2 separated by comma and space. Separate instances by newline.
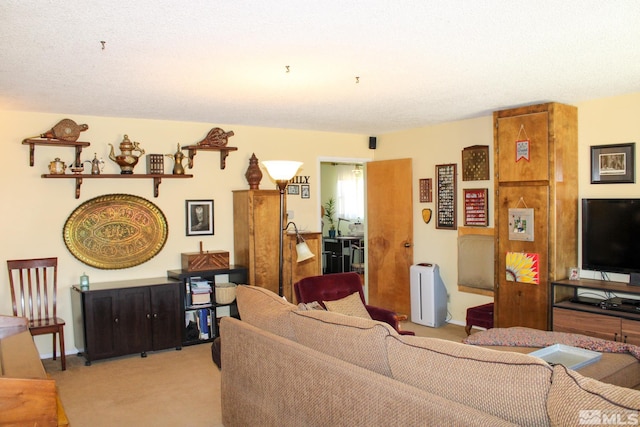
149, 283, 182, 350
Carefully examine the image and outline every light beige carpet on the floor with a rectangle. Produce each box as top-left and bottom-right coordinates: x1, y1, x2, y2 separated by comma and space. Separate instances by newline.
43, 322, 466, 427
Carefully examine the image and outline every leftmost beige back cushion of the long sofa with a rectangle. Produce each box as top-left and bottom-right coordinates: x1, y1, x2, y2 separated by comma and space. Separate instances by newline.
236, 285, 297, 340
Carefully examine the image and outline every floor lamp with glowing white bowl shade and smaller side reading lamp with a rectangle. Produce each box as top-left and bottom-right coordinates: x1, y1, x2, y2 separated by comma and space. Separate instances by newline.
262, 160, 314, 296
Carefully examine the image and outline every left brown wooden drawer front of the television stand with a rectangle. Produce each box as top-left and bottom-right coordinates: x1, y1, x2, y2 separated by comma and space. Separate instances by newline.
553, 308, 621, 341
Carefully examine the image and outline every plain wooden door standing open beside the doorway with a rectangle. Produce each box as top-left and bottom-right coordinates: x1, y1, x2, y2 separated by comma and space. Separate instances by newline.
365, 159, 413, 315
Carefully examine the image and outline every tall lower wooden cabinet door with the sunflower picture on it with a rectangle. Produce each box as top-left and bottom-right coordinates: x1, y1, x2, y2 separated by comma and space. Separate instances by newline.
495, 185, 549, 330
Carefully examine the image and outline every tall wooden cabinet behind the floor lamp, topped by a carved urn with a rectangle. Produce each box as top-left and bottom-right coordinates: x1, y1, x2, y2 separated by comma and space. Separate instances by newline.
233, 190, 286, 293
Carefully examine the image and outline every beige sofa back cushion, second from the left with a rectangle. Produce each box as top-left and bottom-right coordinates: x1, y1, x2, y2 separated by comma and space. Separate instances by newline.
291, 310, 397, 376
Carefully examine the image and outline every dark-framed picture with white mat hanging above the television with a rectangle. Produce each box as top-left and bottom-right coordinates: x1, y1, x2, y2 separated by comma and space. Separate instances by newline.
591, 142, 636, 184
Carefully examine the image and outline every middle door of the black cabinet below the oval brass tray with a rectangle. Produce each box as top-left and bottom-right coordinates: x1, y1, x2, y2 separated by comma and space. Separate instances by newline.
116, 287, 152, 355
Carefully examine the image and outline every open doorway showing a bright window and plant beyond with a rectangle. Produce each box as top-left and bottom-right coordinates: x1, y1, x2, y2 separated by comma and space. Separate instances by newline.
320, 161, 366, 274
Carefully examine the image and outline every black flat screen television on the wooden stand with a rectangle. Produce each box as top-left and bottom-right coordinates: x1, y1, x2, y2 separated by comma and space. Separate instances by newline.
582, 199, 640, 285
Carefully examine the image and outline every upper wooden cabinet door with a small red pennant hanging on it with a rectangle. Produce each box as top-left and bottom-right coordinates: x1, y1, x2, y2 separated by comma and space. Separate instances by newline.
496, 111, 550, 183
